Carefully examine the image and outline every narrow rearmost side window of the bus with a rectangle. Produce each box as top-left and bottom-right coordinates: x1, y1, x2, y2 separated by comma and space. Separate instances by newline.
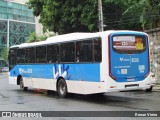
93, 38, 102, 62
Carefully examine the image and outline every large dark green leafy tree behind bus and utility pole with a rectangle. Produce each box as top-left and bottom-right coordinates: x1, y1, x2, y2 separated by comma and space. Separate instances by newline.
27, 0, 140, 31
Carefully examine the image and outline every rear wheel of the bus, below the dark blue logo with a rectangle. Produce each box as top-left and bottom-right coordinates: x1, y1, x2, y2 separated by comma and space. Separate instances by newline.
57, 78, 67, 98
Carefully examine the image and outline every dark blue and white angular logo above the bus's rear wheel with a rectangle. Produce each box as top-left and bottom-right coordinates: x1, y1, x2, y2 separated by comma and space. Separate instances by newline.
53, 65, 71, 80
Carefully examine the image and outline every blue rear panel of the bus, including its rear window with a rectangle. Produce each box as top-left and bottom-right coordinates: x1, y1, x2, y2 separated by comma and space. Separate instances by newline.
109, 33, 149, 82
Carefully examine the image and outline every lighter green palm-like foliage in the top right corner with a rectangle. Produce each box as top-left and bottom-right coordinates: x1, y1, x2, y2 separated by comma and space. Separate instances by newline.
123, 0, 160, 30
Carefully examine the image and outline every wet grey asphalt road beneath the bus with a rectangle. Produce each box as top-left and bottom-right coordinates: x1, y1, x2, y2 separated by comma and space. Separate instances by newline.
0, 74, 160, 120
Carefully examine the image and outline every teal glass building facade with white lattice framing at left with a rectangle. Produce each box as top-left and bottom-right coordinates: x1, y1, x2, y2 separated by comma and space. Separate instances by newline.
0, 0, 36, 65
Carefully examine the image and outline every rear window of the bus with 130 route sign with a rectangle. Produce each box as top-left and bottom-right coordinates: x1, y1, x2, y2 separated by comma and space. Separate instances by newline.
112, 36, 146, 54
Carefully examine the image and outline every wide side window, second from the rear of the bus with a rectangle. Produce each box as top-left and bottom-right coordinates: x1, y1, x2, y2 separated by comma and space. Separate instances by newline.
76, 40, 93, 62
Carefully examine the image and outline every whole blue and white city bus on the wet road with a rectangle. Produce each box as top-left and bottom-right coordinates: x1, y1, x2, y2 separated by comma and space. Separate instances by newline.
9, 30, 150, 97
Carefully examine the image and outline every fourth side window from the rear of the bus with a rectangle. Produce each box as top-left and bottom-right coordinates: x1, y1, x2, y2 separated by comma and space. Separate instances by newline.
47, 44, 59, 63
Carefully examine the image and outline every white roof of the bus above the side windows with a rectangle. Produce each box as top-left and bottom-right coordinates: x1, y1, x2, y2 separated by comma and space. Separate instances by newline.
10, 30, 146, 48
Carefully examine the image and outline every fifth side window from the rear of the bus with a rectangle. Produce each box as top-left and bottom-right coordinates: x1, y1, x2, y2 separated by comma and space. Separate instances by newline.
36, 46, 46, 63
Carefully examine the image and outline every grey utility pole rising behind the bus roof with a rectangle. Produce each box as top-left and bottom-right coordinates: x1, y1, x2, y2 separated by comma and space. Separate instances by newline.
98, 0, 104, 32
